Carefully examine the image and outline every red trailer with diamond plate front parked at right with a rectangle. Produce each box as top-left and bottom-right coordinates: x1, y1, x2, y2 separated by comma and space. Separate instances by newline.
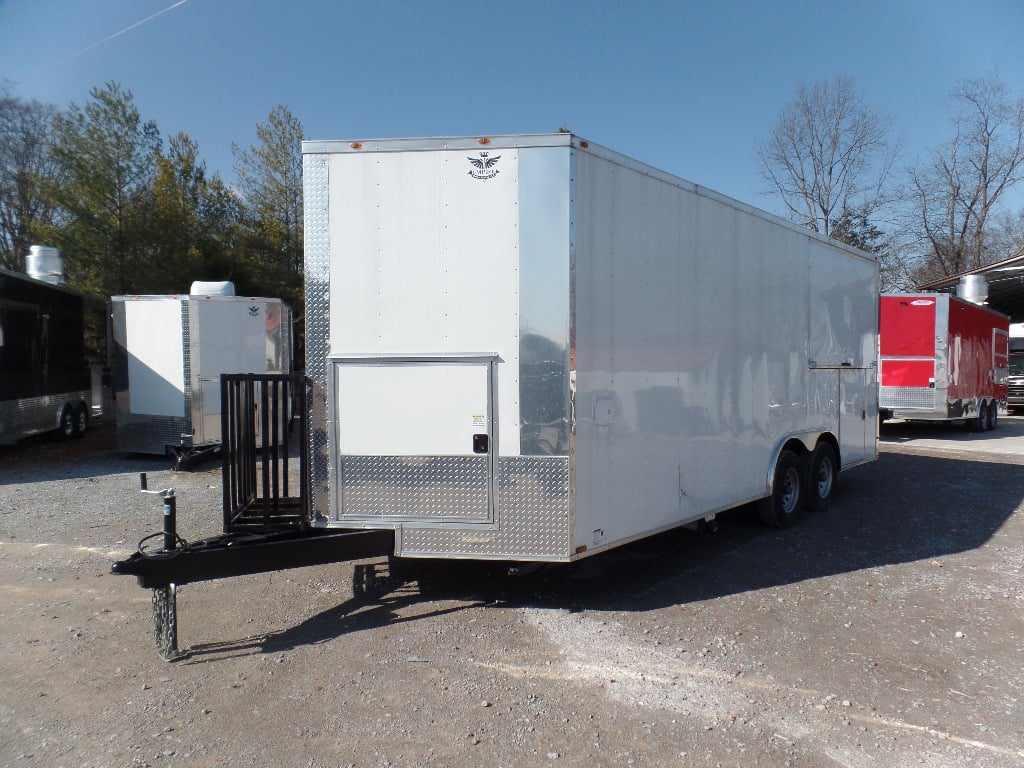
879, 293, 1010, 432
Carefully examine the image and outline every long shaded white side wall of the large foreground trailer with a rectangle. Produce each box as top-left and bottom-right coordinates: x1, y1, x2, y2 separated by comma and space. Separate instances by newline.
573, 145, 877, 548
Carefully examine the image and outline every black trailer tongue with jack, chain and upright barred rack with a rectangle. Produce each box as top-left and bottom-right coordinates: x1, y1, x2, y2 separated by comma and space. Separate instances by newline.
112, 374, 394, 660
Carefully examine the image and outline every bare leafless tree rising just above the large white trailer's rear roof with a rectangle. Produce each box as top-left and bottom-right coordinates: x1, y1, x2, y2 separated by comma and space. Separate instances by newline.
757, 78, 898, 237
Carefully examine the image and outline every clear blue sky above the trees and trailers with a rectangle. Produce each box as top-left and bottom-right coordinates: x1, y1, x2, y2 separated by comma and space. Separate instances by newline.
0, 0, 1024, 218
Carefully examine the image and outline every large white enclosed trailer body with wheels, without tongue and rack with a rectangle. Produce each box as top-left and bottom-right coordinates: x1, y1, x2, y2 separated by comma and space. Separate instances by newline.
303, 133, 878, 561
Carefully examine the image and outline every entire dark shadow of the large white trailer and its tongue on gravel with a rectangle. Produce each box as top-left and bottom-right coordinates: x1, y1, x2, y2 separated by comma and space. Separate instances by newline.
178, 454, 1024, 660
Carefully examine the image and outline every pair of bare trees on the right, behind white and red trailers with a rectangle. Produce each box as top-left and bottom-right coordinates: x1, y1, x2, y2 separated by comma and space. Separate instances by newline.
756, 77, 1024, 291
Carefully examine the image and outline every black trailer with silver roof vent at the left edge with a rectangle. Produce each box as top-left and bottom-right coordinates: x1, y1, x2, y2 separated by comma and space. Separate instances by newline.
0, 246, 105, 442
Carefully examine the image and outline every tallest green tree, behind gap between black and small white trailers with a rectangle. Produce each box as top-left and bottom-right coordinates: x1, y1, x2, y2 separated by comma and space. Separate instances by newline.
45, 82, 161, 296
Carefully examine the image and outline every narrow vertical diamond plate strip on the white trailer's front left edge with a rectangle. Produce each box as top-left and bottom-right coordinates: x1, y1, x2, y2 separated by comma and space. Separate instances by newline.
302, 155, 331, 517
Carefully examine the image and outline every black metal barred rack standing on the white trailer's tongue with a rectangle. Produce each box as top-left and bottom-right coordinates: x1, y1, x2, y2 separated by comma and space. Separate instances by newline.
220, 374, 310, 534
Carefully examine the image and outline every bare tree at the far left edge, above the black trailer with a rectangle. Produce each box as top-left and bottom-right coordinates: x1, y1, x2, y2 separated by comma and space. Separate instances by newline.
0, 87, 60, 271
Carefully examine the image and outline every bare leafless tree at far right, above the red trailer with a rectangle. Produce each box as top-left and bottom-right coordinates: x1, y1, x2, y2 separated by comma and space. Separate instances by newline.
910, 78, 1024, 280
